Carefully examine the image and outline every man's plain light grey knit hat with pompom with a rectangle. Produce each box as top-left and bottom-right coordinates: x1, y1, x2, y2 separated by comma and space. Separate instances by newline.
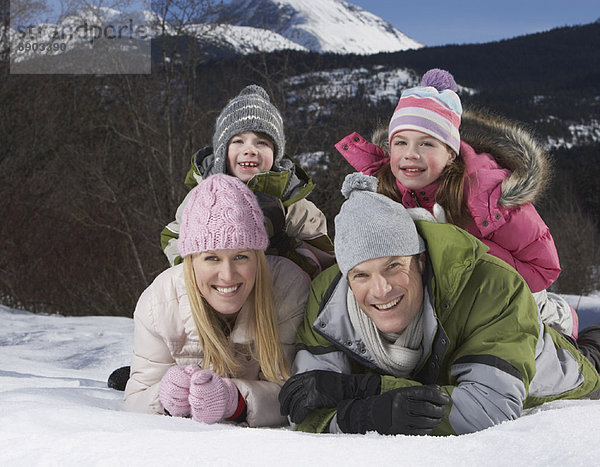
334, 172, 425, 276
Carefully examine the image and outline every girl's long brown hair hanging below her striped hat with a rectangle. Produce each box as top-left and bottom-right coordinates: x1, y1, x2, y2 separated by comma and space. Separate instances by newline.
375, 145, 471, 227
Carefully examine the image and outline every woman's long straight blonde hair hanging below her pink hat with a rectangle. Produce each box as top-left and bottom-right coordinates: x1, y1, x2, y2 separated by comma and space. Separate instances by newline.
183, 254, 290, 382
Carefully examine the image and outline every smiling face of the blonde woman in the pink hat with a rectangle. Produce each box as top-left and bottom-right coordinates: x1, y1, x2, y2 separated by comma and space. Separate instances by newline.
192, 250, 258, 315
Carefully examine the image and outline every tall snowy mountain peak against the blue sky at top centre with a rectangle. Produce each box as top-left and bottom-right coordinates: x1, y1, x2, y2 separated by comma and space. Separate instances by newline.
212, 0, 423, 54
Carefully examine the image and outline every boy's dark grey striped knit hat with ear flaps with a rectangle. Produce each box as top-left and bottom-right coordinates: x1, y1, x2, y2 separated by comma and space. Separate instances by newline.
213, 84, 285, 173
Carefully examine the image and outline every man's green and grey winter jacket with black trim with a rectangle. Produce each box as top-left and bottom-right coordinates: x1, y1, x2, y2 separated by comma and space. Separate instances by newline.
293, 221, 600, 435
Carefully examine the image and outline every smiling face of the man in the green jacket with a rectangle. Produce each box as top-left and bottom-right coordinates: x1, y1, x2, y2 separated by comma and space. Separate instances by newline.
348, 254, 425, 334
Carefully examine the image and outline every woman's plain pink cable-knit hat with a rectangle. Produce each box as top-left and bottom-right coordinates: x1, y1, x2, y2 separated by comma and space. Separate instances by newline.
177, 174, 269, 258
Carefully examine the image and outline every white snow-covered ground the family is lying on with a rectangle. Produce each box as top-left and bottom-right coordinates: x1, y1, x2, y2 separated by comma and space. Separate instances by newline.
0, 297, 600, 467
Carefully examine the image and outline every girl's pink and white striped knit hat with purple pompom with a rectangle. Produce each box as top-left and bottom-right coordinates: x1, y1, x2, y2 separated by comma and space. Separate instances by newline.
388, 68, 462, 154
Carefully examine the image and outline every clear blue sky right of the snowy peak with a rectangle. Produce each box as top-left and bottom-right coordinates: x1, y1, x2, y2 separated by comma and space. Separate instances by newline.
347, 0, 600, 46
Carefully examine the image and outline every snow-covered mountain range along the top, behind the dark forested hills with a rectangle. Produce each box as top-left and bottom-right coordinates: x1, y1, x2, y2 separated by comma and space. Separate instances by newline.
8, 0, 423, 67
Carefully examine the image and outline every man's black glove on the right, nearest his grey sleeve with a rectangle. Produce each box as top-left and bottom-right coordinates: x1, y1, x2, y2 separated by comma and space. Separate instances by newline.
337, 385, 450, 435
